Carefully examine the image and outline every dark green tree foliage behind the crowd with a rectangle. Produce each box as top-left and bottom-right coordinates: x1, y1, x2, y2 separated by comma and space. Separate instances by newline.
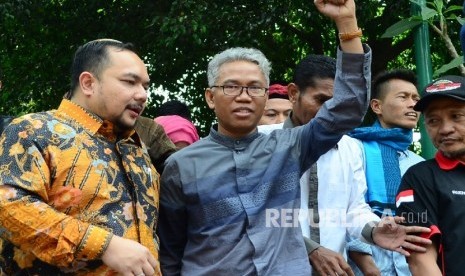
0, 0, 461, 134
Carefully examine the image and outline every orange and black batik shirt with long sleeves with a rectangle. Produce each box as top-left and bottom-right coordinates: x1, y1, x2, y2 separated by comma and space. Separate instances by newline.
0, 100, 159, 275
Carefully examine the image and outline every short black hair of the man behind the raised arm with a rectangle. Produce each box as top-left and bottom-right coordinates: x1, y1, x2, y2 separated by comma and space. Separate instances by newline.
293, 55, 336, 91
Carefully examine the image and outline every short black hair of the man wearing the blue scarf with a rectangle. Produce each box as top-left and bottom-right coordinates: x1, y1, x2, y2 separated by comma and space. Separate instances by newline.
371, 69, 417, 99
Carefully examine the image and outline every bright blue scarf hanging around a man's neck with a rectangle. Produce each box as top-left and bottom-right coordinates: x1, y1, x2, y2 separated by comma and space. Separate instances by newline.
349, 121, 413, 217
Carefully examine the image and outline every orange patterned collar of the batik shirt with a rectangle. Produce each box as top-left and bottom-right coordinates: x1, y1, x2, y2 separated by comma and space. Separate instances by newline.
58, 99, 139, 141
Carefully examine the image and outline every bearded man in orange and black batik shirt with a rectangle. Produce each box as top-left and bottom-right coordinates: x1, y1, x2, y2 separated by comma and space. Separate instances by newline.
0, 39, 160, 275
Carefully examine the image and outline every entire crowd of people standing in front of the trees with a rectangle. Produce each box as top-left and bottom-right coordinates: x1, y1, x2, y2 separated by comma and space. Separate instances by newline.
0, 0, 465, 276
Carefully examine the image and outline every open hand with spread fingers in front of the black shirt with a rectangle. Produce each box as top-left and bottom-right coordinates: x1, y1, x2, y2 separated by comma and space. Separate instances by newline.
372, 216, 431, 257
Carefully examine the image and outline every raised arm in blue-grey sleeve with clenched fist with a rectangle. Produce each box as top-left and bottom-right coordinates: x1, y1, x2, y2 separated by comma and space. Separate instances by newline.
302, 0, 371, 168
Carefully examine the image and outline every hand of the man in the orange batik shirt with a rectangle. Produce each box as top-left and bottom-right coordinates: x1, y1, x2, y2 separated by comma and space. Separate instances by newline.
102, 236, 157, 276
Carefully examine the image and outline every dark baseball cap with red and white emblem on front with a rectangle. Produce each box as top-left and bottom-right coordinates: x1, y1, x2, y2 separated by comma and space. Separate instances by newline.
413, 76, 465, 111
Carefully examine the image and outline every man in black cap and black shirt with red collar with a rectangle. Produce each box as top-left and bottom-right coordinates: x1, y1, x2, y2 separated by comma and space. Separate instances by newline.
396, 76, 465, 275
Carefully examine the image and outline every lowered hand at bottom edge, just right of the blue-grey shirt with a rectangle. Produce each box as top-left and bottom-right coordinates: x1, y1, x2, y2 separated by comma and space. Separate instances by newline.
308, 246, 354, 276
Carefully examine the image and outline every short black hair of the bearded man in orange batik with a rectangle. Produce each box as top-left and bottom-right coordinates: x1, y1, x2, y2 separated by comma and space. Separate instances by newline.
68, 39, 135, 97
